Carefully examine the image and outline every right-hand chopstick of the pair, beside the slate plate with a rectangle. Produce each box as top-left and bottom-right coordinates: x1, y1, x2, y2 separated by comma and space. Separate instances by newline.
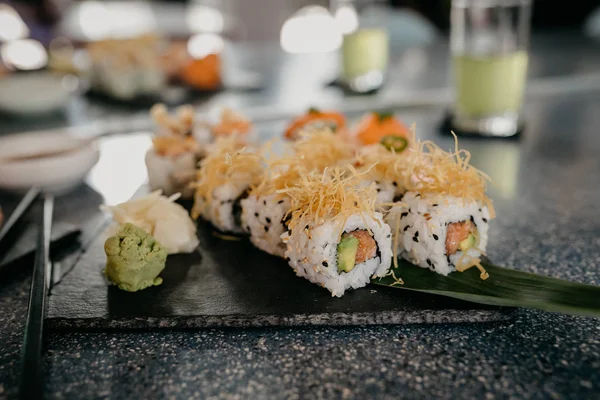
19, 194, 54, 399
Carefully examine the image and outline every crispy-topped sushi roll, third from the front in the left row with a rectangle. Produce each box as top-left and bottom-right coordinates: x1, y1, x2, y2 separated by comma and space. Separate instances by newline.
192, 136, 264, 234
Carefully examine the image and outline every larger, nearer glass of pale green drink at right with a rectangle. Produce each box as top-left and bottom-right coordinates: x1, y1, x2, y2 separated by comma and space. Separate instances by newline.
450, 0, 531, 136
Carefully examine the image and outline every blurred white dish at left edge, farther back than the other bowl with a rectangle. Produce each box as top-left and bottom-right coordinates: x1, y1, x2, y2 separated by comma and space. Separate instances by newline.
0, 72, 71, 115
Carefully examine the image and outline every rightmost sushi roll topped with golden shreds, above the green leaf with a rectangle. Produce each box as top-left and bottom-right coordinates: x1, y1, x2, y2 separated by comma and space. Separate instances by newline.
386, 137, 495, 279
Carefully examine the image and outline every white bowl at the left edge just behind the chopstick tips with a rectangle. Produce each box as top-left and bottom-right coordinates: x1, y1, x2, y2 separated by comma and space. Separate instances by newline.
0, 132, 100, 193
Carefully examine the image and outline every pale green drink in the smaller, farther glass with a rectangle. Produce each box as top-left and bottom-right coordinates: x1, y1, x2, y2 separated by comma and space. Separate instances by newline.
342, 28, 388, 92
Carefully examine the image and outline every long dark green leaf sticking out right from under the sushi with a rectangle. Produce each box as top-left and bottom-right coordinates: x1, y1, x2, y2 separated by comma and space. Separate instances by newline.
372, 260, 600, 317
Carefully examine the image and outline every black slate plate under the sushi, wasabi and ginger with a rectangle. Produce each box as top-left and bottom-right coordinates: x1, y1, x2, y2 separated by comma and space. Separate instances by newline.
47, 220, 510, 330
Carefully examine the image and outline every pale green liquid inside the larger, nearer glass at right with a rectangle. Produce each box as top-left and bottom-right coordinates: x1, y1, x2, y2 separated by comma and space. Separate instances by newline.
453, 51, 527, 117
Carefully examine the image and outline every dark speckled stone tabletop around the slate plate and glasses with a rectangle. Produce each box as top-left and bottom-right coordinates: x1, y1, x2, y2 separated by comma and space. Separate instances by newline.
0, 29, 600, 398
